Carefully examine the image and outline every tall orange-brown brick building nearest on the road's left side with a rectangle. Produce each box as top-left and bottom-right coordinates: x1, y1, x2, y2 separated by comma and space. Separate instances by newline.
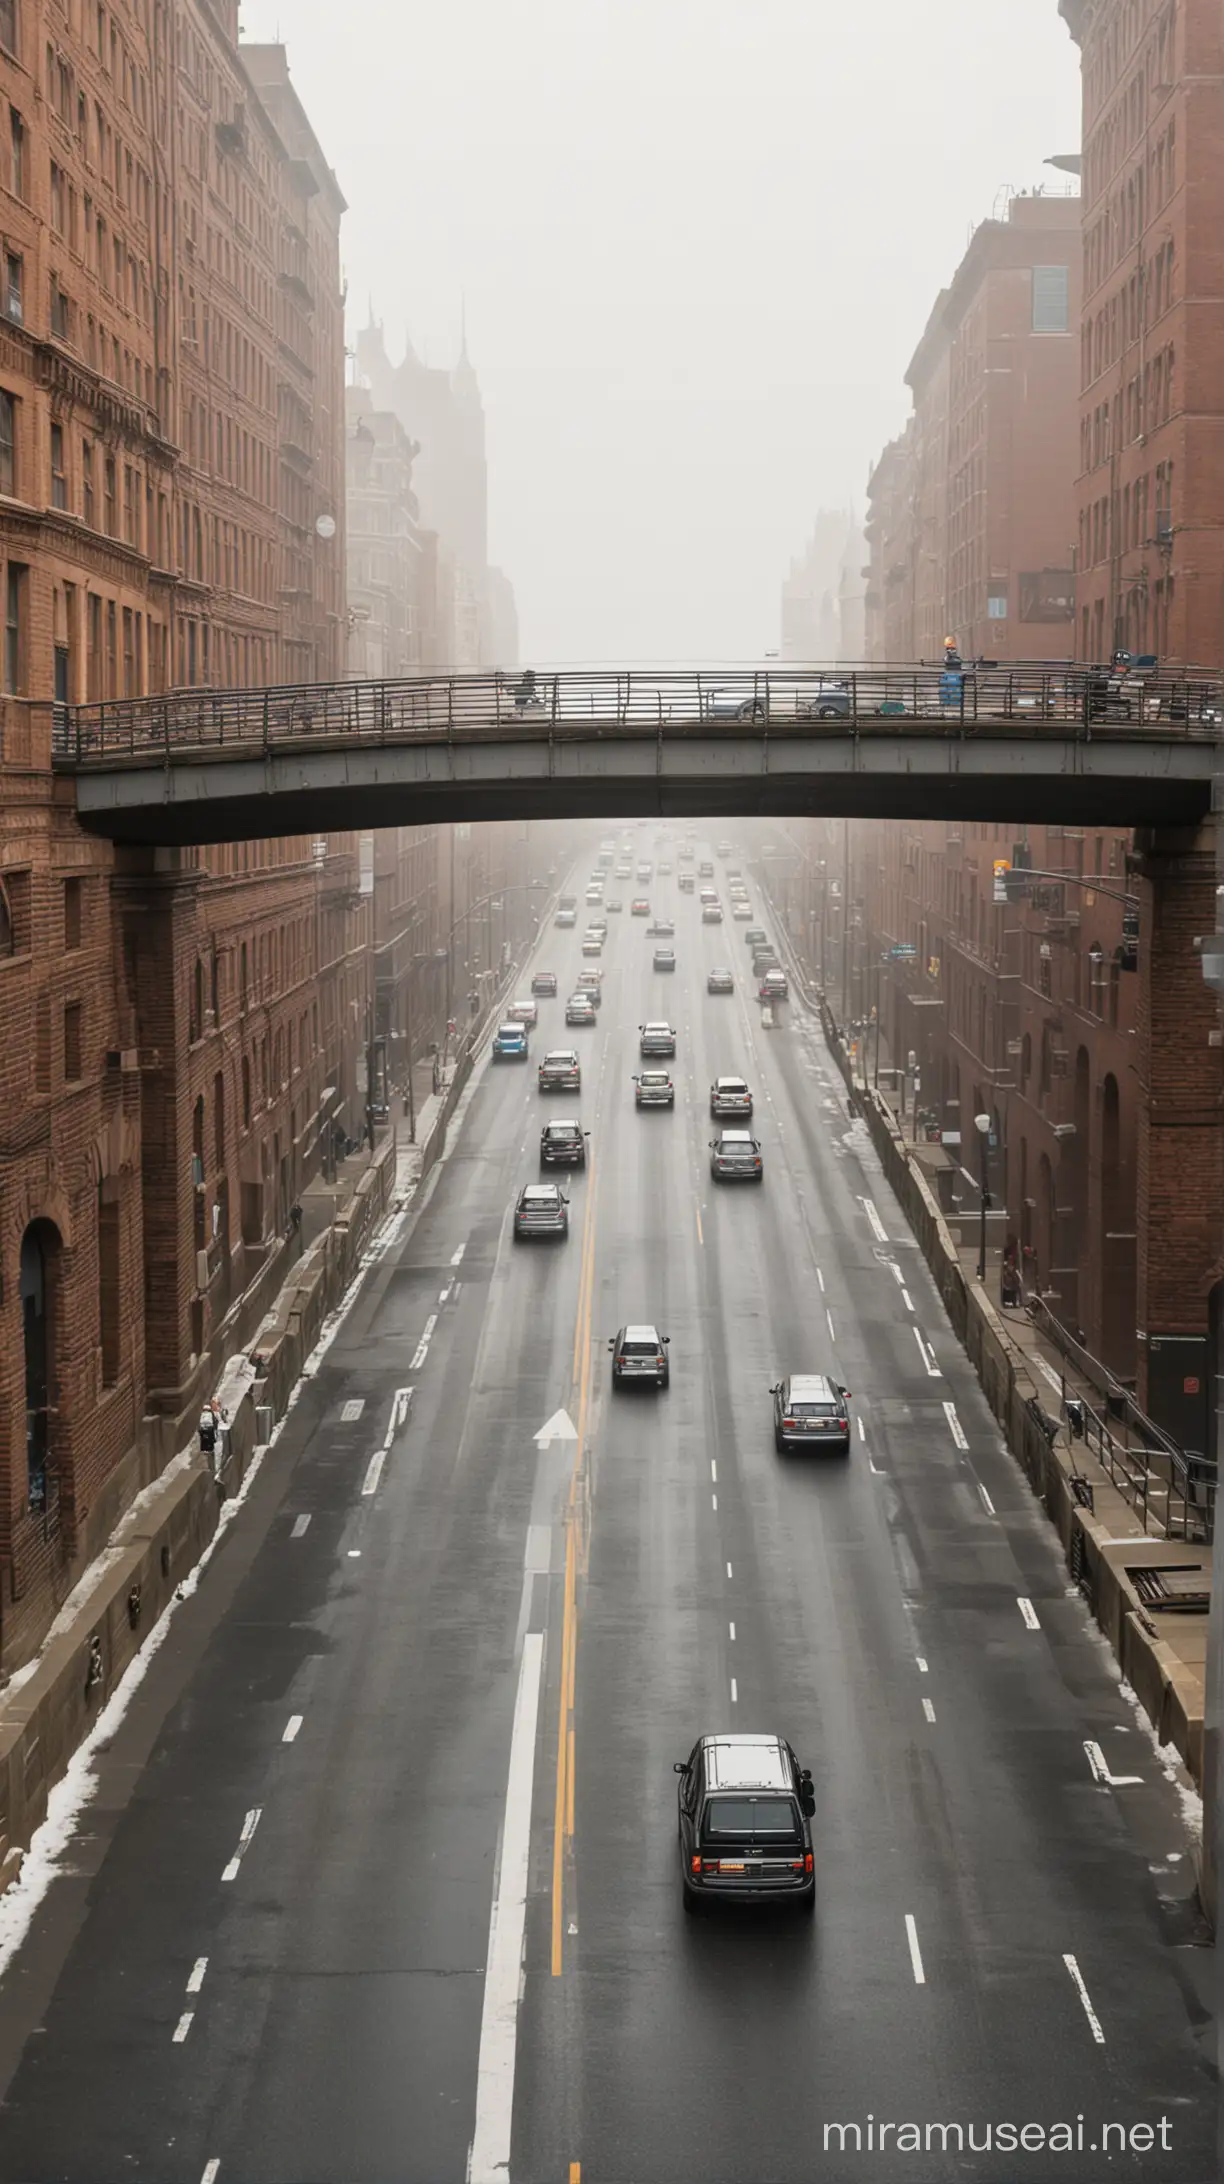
0, 0, 374, 1671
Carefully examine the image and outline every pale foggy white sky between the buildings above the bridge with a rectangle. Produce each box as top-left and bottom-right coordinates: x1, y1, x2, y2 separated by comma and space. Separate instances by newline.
233, 0, 1080, 662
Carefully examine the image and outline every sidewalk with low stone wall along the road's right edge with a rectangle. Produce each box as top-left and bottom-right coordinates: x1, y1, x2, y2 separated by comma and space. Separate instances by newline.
763, 891, 1211, 1789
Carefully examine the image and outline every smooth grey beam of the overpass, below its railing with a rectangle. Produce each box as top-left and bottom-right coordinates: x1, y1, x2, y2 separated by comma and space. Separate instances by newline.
64, 727, 1220, 847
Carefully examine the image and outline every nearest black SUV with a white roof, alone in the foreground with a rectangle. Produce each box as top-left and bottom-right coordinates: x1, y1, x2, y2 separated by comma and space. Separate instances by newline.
673, 1730, 815, 1913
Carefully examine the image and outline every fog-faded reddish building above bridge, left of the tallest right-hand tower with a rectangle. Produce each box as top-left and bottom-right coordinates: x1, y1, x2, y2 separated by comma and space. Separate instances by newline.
868, 194, 1080, 660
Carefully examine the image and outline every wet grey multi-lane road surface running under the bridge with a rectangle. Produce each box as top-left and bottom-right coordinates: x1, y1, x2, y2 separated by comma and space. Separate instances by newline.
0, 828, 1215, 2184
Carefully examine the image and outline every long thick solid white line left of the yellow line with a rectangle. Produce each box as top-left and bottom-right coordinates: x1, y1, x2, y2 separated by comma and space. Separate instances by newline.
468, 1631, 544, 2184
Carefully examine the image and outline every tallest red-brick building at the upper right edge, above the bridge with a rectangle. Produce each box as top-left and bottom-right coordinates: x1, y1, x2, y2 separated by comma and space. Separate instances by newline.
1060, 0, 1224, 666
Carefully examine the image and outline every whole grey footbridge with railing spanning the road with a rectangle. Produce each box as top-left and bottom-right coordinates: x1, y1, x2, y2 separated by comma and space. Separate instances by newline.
52, 666, 1224, 845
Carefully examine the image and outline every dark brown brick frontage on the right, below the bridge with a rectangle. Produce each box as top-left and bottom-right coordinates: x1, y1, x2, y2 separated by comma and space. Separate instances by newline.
773, 821, 1224, 1450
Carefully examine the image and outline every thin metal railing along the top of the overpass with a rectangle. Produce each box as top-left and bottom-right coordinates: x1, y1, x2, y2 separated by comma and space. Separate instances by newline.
52, 662, 1224, 767
